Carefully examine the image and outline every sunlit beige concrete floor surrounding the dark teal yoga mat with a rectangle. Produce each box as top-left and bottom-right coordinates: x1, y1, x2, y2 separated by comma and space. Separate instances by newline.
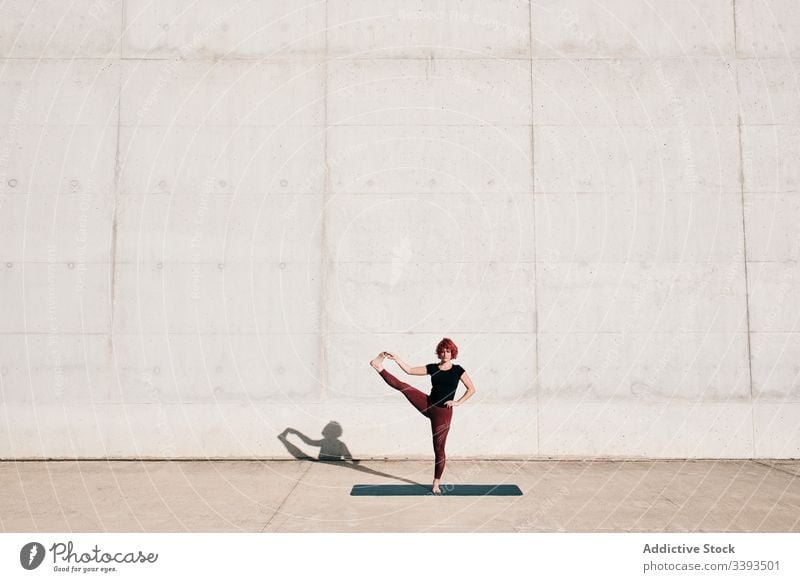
0, 461, 800, 532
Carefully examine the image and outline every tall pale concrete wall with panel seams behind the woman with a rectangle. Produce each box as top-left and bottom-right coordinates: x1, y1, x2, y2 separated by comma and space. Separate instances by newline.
0, 0, 800, 458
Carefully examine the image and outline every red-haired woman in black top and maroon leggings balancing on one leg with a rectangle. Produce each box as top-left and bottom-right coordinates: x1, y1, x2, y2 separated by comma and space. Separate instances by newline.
370, 338, 475, 494
